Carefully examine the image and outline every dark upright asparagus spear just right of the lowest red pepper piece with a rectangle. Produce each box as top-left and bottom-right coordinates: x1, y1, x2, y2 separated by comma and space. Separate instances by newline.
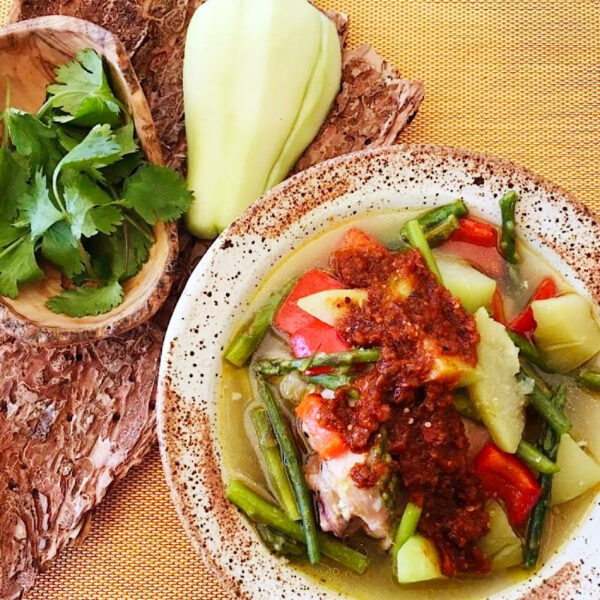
523, 384, 566, 569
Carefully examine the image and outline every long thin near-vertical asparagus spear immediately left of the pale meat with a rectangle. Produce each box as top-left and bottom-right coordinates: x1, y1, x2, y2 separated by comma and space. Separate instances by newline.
257, 376, 321, 565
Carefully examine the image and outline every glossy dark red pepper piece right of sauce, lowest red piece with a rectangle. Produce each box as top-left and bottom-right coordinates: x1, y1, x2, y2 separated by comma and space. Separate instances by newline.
475, 442, 542, 527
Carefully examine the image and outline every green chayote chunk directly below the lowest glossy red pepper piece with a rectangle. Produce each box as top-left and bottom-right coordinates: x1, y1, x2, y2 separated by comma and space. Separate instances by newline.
479, 500, 523, 570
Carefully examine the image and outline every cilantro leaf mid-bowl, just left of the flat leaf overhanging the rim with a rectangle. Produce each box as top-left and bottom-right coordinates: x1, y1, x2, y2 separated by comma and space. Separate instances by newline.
64, 174, 123, 239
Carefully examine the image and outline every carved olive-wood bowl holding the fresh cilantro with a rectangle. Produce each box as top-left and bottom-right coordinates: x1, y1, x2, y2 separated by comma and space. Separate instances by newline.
0, 16, 178, 345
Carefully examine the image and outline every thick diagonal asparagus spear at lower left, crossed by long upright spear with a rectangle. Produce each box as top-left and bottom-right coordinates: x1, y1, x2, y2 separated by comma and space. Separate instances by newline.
226, 480, 369, 574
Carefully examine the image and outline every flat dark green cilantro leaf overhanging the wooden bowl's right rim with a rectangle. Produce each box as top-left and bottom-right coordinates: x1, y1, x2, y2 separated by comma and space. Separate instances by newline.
122, 164, 193, 225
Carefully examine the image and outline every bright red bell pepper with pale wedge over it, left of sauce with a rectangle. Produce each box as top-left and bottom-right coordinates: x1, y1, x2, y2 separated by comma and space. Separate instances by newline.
273, 270, 350, 358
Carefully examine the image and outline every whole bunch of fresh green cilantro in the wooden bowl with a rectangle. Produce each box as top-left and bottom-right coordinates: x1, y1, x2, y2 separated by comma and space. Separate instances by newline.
0, 49, 192, 318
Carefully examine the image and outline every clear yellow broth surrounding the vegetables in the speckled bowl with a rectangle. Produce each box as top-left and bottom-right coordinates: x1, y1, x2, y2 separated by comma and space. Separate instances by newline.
218, 211, 600, 600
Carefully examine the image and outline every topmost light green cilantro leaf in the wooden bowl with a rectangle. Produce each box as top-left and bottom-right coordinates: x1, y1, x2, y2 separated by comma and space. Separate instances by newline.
48, 48, 120, 127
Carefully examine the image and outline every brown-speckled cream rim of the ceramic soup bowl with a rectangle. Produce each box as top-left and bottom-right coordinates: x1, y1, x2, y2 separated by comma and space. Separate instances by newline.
157, 144, 600, 600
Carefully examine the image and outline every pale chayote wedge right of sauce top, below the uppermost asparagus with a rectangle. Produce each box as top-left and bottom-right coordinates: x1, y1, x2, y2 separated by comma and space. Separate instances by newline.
437, 255, 496, 313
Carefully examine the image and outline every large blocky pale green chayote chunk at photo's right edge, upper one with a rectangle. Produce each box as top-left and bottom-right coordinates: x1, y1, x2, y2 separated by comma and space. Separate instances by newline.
531, 294, 600, 373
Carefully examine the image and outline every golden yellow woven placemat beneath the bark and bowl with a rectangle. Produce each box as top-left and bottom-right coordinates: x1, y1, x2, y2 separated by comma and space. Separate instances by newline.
0, 0, 600, 600
